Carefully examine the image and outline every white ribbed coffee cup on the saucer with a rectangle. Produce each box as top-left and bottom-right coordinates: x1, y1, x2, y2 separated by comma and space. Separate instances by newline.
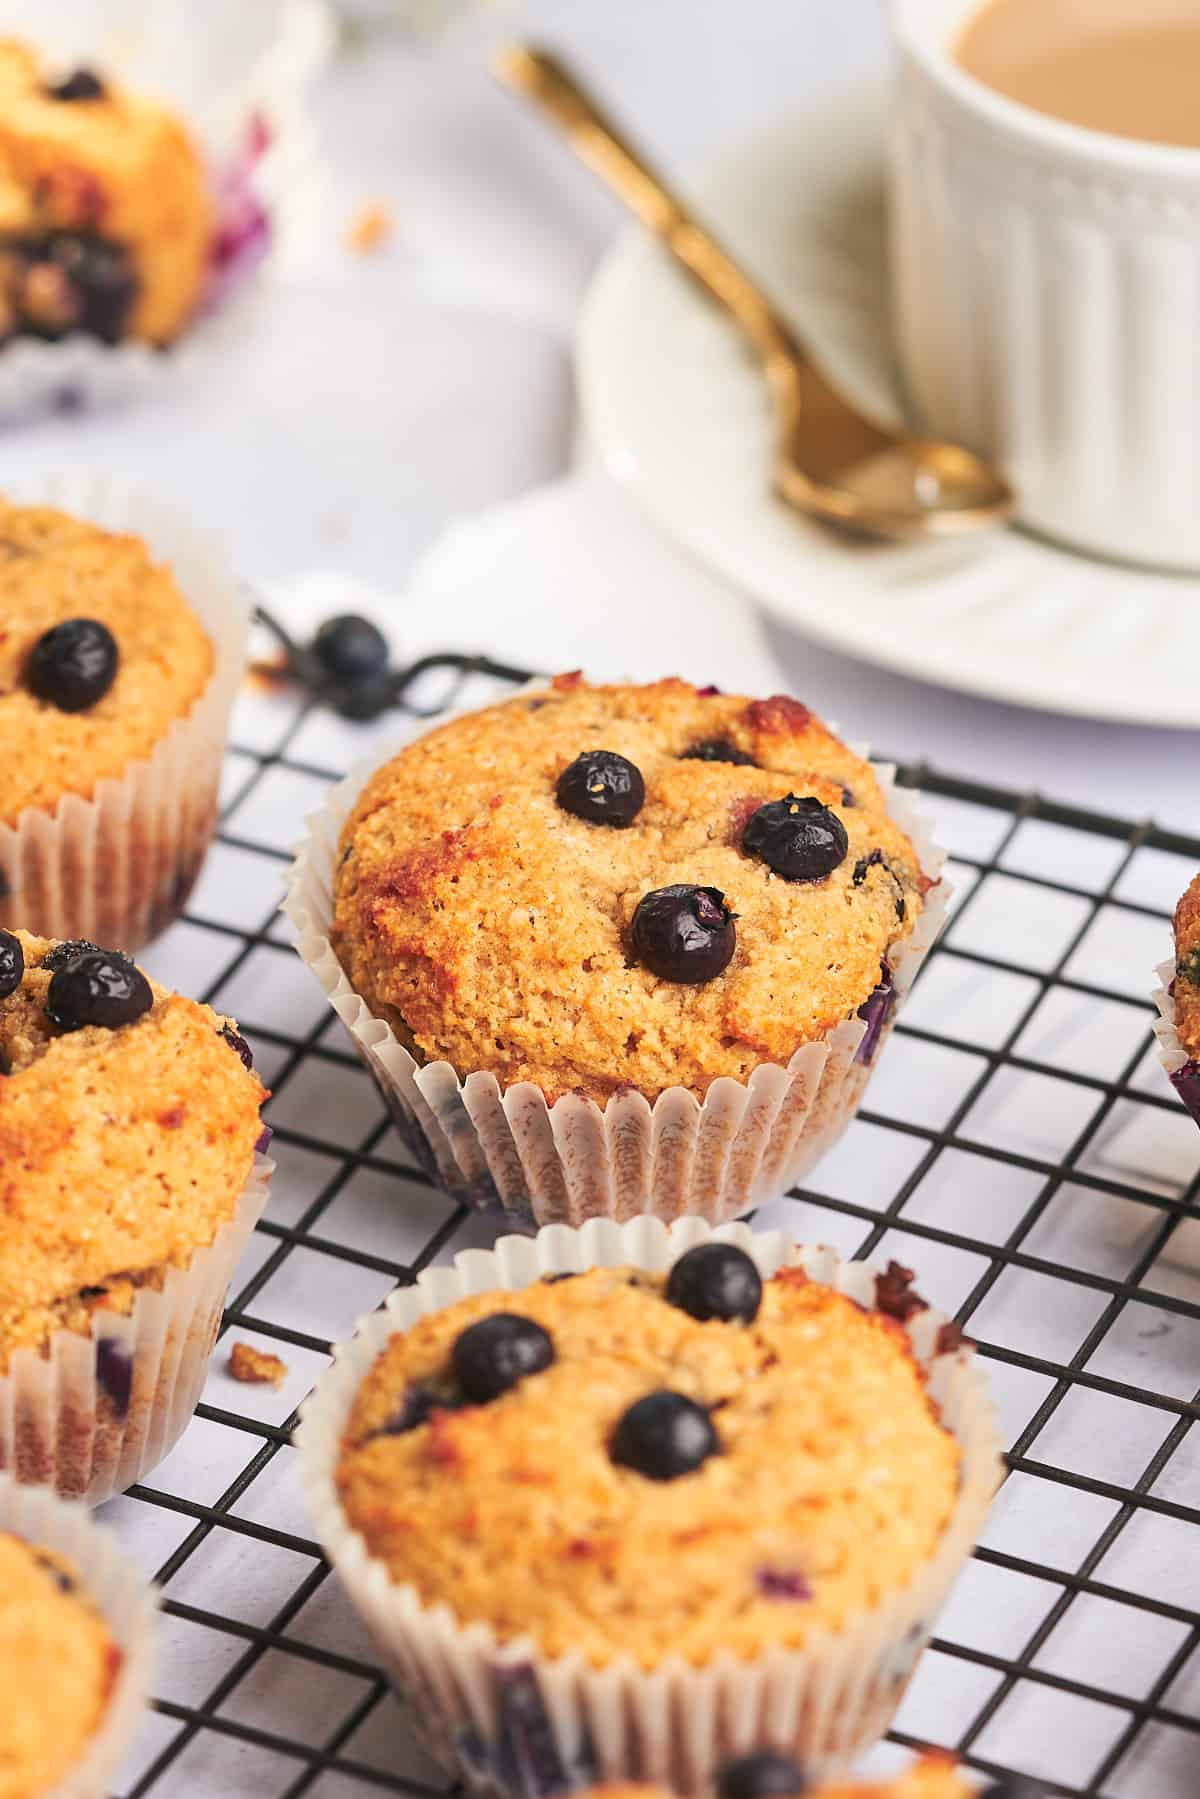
889, 0, 1200, 568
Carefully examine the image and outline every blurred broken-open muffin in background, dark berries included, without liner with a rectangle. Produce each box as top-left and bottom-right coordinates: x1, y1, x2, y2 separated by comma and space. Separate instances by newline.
0, 40, 214, 344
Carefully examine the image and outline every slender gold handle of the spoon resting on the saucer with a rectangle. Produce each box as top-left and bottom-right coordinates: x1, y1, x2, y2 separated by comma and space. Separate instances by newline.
495, 43, 804, 374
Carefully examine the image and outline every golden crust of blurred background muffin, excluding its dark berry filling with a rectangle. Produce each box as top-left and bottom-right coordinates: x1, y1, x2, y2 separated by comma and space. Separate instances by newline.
0, 38, 212, 344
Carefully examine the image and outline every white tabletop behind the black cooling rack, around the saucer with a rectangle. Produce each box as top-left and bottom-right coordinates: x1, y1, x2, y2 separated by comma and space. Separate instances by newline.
0, 0, 1200, 831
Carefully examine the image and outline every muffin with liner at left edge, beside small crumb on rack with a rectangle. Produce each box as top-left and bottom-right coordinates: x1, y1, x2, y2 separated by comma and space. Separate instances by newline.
0, 932, 266, 1497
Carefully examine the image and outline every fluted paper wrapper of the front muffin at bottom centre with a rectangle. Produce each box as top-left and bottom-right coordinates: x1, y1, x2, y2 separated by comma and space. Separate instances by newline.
297, 1218, 1002, 1799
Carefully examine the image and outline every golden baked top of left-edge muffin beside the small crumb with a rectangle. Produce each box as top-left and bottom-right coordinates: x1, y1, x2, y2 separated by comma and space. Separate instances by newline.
0, 932, 266, 1371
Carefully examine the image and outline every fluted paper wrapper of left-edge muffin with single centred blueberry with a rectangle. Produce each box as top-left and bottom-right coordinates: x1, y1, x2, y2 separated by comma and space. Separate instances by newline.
0, 473, 250, 950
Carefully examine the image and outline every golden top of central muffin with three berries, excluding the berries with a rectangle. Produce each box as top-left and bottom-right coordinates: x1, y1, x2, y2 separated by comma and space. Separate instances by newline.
333, 676, 928, 1103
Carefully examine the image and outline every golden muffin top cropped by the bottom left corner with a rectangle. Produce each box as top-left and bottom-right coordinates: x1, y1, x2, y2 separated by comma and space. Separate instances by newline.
0, 1531, 122, 1799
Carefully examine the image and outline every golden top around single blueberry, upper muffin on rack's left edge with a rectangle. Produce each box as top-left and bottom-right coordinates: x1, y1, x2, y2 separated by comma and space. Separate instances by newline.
0, 500, 214, 824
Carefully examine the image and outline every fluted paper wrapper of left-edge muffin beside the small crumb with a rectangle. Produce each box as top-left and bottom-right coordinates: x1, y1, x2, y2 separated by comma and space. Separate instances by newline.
0, 1155, 275, 1506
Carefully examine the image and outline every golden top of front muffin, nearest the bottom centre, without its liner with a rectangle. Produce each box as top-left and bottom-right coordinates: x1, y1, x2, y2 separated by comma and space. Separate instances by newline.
336, 1265, 959, 1668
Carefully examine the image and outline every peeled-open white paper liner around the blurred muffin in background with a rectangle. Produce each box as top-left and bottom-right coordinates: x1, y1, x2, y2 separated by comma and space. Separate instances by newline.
0, 0, 336, 425
